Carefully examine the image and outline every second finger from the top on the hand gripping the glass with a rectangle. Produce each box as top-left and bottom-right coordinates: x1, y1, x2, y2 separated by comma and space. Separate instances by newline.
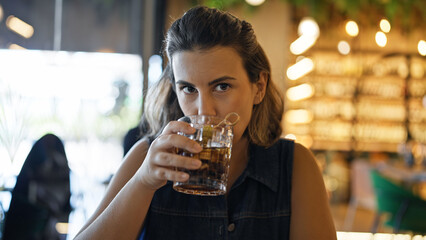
151, 134, 203, 153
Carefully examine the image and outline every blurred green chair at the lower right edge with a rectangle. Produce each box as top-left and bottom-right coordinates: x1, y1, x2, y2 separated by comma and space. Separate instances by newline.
370, 170, 426, 234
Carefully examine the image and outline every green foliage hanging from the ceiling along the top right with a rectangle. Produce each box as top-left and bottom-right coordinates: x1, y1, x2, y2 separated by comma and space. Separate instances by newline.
198, 0, 426, 30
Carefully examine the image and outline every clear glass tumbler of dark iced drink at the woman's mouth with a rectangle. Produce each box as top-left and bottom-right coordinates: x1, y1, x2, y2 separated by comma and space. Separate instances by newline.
173, 115, 238, 196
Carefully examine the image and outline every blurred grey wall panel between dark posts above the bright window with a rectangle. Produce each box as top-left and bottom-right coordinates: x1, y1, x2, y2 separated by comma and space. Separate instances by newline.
61, 0, 130, 53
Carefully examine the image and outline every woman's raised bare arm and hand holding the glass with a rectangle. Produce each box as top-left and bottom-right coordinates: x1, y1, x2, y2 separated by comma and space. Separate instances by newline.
75, 122, 202, 240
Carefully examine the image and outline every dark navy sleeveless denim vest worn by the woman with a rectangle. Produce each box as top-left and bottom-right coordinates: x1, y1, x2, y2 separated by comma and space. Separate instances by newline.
139, 139, 294, 240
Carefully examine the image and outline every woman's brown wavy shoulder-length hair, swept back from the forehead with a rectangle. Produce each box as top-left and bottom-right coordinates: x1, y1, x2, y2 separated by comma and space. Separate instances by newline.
141, 6, 284, 146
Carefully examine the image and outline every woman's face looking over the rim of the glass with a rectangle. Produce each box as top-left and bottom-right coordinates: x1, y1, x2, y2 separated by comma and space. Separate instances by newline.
172, 47, 263, 143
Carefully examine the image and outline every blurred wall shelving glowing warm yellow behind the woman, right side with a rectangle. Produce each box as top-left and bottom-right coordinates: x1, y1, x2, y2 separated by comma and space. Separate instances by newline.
284, 50, 426, 152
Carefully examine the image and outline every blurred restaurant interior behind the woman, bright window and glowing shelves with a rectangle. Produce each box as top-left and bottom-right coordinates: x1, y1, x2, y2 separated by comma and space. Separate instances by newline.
0, 0, 426, 239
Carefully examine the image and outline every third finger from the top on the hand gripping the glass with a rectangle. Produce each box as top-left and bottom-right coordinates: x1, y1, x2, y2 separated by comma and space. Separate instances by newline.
153, 152, 201, 169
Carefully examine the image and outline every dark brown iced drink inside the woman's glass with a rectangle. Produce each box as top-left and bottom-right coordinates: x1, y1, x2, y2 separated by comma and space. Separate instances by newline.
173, 147, 231, 195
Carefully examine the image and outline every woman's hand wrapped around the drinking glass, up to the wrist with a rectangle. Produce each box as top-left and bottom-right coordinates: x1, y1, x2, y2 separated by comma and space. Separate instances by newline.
136, 121, 202, 190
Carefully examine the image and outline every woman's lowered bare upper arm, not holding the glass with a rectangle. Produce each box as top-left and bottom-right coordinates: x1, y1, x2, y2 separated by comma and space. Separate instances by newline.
290, 143, 336, 240
